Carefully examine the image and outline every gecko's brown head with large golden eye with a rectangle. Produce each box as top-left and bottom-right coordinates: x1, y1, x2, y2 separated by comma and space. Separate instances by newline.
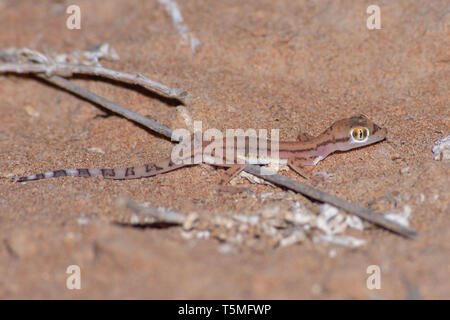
330, 114, 387, 151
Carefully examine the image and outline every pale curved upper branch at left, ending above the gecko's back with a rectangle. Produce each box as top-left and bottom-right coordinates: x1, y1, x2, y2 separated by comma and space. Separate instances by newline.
0, 63, 189, 103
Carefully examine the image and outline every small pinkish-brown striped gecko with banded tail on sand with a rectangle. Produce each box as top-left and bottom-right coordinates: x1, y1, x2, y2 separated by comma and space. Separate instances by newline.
14, 115, 387, 185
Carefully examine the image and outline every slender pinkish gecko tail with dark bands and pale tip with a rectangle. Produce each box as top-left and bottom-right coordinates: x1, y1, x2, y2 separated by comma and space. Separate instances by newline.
14, 159, 187, 182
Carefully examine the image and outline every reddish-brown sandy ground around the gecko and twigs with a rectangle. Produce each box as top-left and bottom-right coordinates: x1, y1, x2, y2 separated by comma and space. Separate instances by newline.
0, 0, 450, 299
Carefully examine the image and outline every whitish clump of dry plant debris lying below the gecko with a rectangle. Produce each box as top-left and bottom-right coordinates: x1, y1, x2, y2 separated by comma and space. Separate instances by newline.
117, 198, 376, 253
